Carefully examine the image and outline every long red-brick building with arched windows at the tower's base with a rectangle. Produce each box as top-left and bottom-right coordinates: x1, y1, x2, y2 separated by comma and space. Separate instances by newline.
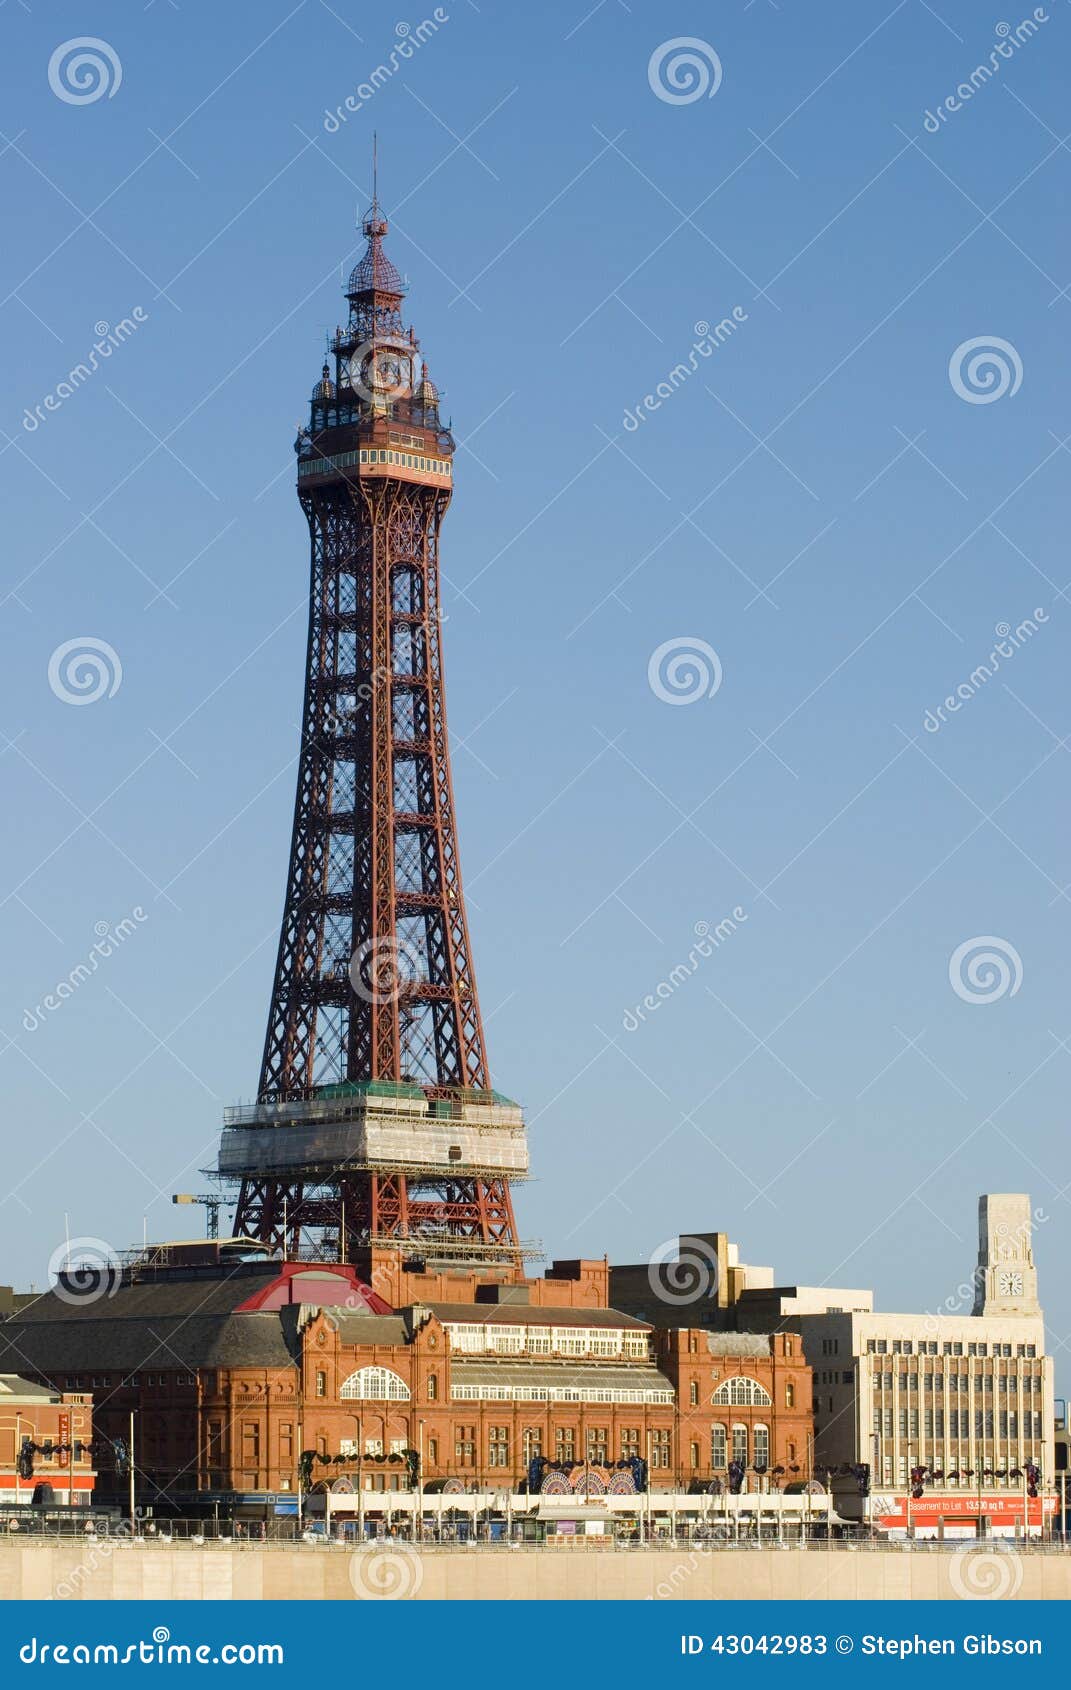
0, 1244, 811, 1518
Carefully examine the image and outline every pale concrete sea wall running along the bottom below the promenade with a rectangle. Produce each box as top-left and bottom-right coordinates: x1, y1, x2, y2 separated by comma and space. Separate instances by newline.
0, 1541, 1071, 1602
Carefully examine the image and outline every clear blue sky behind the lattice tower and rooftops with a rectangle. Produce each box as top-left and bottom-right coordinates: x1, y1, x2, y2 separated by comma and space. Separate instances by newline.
0, 0, 1071, 1354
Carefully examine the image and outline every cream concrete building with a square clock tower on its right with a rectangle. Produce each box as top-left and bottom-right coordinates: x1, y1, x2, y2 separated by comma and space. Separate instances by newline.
799, 1195, 1056, 1529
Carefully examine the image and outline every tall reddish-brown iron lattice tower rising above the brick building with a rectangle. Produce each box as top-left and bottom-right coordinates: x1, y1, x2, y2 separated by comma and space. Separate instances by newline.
218, 185, 527, 1273
